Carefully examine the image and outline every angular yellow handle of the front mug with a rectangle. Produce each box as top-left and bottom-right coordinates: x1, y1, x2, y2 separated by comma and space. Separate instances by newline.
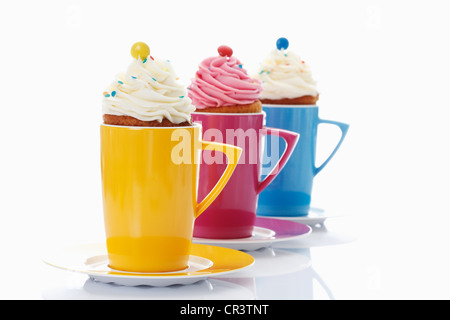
195, 141, 242, 219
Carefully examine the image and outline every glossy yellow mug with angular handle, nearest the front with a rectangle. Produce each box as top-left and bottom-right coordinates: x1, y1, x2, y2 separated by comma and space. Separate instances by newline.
101, 124, 242, 272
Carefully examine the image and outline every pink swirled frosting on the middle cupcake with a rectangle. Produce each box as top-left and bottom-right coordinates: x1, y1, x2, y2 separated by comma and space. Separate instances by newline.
188, 56, 262, 109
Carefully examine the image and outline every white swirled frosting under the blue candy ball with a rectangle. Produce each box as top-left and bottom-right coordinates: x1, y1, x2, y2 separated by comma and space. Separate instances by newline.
254, 50, 319, 100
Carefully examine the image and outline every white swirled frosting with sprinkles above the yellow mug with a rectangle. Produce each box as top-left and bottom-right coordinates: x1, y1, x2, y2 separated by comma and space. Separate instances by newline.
103, 58, 195, 124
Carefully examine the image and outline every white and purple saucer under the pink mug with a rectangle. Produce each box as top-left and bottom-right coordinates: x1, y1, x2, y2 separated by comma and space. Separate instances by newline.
192, 217, 312, 251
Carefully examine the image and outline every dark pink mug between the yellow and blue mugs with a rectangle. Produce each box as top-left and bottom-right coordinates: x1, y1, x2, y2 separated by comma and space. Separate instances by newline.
192, 112, 299, 239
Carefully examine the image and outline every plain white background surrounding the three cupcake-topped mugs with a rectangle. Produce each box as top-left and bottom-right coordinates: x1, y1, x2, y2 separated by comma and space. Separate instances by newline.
0, 0, 450, 298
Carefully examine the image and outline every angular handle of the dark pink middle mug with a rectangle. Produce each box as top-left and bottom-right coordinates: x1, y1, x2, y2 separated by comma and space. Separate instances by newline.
257, 127, 300, 194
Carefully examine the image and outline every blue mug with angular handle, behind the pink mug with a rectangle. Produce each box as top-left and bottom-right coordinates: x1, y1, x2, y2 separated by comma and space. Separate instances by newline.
257, 105, 349, 217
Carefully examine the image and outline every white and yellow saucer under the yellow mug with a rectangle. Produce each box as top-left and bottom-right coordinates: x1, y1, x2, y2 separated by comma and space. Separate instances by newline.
43, 244, 255, 287
